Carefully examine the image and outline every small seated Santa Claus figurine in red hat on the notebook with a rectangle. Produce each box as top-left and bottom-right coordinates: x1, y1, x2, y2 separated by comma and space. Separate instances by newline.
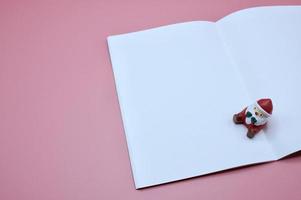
233, 99, 273, 138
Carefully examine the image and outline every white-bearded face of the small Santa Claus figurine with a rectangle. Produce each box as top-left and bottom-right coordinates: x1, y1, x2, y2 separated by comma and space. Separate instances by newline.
245, 104, 268, 126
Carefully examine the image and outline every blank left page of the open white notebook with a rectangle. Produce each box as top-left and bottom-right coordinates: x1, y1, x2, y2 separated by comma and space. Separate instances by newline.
108, 22, 275, 188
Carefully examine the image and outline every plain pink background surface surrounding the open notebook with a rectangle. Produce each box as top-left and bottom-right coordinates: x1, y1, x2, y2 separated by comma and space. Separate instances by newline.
0, 0, 301, 200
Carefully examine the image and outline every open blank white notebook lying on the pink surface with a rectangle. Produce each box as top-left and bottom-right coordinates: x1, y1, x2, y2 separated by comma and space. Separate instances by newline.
108, 6, 301, 188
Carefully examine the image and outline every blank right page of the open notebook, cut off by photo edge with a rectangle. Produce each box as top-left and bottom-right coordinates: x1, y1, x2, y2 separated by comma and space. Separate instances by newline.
217, 6, 301, 158
